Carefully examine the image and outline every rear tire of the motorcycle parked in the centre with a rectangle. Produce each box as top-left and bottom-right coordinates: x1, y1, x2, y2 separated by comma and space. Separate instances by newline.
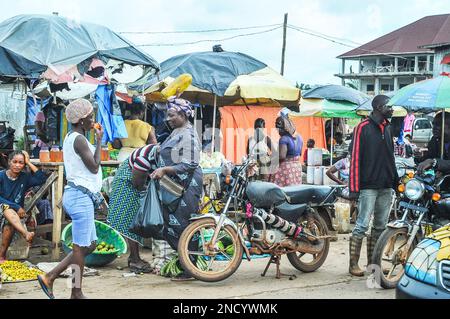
287, 213, 330, 273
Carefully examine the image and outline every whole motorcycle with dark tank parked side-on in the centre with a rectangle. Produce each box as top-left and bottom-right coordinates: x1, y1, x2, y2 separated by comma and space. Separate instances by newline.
178, 159, 341, 282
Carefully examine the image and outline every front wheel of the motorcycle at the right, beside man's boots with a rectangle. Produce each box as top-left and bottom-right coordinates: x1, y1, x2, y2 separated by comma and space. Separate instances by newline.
371, 228, 417, 289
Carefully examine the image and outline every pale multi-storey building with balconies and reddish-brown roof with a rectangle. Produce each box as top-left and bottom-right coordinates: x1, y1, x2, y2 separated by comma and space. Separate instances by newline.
336, 14, 450, 95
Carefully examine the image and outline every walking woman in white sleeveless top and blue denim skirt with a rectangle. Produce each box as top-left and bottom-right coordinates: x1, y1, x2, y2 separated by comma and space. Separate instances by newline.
38, 99, 103, 299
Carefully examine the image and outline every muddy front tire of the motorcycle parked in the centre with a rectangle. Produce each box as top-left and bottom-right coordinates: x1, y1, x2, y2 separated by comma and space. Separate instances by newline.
178, 219, 244, 282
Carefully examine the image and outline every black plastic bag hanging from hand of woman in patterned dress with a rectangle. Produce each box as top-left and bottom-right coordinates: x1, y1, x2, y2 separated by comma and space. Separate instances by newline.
129, 180, 164, 240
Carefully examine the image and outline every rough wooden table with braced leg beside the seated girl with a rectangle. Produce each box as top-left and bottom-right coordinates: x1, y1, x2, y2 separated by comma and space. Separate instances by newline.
29, 159, 121, 261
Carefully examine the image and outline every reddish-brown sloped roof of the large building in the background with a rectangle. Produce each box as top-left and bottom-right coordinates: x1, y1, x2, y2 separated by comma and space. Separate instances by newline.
338, 14, 450, 58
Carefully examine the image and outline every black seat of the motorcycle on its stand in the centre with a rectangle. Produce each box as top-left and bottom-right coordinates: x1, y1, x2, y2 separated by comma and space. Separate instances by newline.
282, 185, 335, 204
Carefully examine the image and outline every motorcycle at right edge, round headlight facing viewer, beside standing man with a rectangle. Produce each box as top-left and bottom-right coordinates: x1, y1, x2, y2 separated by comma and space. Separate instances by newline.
371, 166, 450, 289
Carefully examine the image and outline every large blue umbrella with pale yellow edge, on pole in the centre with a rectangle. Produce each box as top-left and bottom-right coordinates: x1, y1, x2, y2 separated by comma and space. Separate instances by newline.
129, 51, 300, 152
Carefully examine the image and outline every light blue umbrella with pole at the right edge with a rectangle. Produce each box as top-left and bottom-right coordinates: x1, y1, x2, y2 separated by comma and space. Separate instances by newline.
389, 73, 450, 157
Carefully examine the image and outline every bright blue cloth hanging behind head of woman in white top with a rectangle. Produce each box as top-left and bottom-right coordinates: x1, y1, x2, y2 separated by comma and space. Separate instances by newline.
95, 85, 128, 144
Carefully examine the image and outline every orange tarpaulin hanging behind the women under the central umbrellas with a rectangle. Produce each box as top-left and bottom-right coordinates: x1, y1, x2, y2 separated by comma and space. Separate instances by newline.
219, 106, 326, 163
